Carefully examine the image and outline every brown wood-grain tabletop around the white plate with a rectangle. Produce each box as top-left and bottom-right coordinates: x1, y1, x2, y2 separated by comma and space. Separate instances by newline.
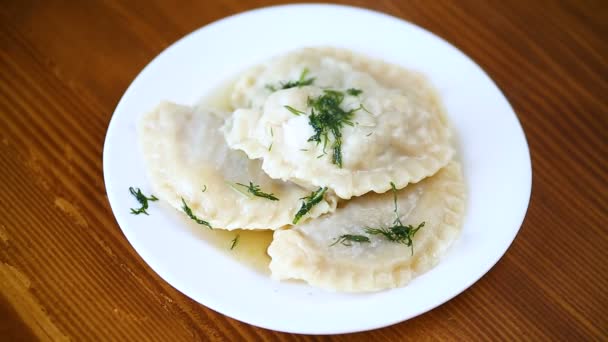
0, 0, 608, 341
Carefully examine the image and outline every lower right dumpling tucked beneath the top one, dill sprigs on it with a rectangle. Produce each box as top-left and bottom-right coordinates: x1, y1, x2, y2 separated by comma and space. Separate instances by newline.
268, 162, 465, 292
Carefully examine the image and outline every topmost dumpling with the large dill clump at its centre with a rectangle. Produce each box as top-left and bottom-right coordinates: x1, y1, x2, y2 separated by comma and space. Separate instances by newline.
224, 48, 454, 199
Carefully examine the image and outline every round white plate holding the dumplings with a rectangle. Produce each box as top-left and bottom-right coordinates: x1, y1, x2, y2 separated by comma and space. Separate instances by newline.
104, 5, 532, 334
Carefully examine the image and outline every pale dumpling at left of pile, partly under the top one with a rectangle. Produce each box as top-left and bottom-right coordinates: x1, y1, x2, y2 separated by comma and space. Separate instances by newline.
138, 102, 336, 230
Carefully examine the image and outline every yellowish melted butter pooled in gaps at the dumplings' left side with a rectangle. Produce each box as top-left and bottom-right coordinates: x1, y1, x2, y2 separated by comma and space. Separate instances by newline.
187, 79, 273, 275
